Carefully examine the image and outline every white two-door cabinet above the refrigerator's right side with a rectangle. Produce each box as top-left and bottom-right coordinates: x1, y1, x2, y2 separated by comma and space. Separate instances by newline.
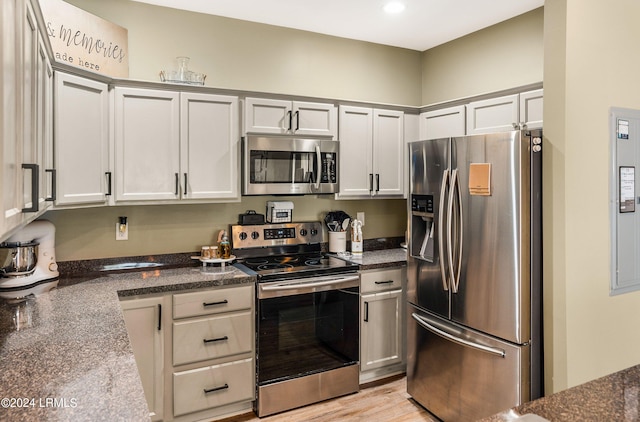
467, 89, 543, 135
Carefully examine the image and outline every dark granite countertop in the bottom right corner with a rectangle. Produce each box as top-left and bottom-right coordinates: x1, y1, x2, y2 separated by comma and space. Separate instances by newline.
481, 365, 640, 422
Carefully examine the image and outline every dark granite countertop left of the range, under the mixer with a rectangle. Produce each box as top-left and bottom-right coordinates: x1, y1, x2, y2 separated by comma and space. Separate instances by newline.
0, 266, 255, 421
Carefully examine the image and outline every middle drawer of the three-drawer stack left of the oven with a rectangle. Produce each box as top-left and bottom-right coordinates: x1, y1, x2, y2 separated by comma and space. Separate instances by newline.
173, 312, 254, 365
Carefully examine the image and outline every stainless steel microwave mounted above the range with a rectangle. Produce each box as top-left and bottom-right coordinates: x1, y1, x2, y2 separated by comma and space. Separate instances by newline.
242, 136, 340, 195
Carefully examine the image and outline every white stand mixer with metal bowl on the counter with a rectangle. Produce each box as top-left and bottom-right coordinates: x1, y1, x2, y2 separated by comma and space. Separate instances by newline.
0, 220, 59, 299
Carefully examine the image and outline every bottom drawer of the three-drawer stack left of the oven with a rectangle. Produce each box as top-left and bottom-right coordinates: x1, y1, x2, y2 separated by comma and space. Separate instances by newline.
173, 358, 254, 416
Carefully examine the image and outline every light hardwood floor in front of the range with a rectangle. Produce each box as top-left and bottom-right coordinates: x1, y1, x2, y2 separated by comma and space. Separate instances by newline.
224, 377, 438, 422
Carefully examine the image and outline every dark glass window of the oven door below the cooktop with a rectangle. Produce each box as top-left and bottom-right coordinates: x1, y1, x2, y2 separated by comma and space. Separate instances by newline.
257, 287, 360, 385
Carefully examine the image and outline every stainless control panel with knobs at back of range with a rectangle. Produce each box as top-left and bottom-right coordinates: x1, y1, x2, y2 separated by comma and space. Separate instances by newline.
231, 221, 322, 249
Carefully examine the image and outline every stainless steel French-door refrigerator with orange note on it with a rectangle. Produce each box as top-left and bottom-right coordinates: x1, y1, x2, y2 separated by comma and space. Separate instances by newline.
407, 130, 543, 421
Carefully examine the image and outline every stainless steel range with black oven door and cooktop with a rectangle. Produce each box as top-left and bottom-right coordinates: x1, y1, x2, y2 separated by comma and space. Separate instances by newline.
231, 222, 360, 417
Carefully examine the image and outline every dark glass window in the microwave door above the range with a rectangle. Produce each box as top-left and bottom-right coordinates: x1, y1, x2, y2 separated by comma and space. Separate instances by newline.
249, 150, 317, 183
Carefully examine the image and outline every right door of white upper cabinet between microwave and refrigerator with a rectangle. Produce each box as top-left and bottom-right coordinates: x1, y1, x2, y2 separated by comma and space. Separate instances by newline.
373, 109, 405, 196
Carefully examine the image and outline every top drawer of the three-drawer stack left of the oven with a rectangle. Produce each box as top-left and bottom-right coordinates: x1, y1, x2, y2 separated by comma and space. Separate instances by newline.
173, 285, 253, 319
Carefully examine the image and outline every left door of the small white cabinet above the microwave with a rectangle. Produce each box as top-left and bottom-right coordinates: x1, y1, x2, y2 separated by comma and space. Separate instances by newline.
244, 98, 293, 135
